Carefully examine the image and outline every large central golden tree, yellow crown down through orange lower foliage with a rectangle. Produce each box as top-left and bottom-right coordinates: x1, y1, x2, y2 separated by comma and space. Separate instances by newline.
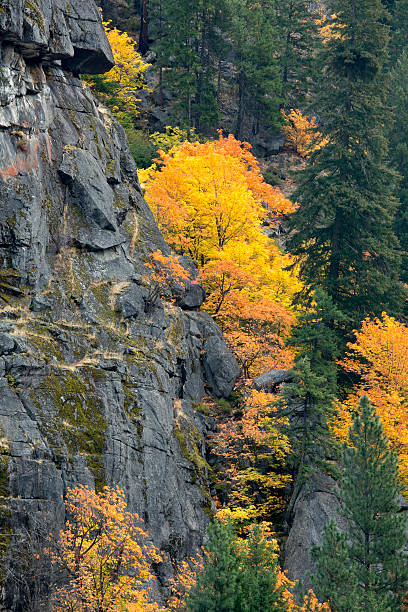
145, 134, 300, 377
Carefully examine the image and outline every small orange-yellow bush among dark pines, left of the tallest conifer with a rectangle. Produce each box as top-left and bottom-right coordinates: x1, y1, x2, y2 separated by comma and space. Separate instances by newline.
281, 108, 328, 158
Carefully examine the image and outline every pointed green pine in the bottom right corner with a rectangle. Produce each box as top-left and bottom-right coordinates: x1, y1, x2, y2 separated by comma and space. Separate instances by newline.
313, 396, 408, 612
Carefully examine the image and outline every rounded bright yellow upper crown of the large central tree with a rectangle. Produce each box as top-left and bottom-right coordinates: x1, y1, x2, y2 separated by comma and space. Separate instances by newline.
145, 136, 293, 264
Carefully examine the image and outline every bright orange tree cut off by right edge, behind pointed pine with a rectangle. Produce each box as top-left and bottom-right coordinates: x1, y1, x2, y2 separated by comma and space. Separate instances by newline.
332, 313, 408, 489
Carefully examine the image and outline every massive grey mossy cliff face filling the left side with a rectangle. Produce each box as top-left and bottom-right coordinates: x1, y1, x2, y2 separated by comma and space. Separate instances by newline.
0, 0, 238, 610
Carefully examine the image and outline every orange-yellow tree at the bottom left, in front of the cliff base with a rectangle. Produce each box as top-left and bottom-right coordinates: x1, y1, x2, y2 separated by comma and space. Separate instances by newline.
50, 485, 161, 612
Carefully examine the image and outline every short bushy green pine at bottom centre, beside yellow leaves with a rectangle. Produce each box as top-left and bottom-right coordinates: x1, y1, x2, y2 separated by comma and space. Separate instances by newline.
187, 521, 288, 612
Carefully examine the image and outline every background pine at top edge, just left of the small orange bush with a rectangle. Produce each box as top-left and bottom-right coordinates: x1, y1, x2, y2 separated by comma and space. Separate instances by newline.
227, 0, 282, 138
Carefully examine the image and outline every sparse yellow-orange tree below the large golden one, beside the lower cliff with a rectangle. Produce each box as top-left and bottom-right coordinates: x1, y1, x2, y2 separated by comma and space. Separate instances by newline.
212, 390, 291, 528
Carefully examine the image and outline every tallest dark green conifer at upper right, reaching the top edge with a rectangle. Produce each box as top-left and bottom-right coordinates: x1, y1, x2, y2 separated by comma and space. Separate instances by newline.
288, 0, 404, 335
